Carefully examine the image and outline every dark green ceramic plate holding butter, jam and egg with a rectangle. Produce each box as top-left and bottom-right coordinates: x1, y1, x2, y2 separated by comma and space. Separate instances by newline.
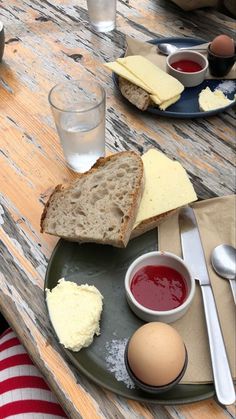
45, 230, 215, 404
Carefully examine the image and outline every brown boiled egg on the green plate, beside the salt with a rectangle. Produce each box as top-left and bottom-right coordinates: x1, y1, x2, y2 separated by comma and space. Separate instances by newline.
127, 322, 186, 387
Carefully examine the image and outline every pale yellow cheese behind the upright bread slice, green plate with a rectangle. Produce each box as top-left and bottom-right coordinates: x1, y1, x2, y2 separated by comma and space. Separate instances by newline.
133, 149, 197, 228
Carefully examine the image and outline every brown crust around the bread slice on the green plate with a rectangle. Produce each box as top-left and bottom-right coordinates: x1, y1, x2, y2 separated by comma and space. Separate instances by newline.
40, 151, 144, 247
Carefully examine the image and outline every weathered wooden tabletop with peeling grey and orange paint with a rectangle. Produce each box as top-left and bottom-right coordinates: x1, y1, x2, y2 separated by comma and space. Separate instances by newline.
0, 0, 235, 419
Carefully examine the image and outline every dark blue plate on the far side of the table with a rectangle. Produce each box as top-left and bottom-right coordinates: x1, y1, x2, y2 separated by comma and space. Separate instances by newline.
113, 38, 236, 118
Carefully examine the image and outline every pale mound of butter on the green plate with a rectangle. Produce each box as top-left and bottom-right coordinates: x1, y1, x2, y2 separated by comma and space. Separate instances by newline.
46, 278, 103, 351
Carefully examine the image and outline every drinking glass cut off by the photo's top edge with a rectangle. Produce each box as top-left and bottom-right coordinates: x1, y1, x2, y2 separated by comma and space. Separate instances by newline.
87, 0, 116, 32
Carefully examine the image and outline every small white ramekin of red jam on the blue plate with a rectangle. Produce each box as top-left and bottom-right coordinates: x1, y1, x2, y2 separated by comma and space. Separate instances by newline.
166, 50, 208, 87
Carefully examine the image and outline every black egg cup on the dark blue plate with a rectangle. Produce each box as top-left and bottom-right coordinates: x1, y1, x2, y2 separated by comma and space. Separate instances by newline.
207, 44, 236, 77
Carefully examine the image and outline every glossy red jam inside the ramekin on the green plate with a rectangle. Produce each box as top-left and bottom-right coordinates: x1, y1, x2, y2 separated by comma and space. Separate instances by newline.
131, 265, 187, 311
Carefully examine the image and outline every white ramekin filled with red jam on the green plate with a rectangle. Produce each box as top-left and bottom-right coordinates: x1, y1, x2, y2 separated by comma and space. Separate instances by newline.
125, 251, 195, 323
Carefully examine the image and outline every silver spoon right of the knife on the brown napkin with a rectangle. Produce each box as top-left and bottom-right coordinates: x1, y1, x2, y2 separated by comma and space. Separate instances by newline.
211, 244, 236, 304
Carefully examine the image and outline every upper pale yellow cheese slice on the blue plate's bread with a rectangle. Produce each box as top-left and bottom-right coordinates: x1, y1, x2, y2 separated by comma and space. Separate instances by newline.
117, 55, 184, 103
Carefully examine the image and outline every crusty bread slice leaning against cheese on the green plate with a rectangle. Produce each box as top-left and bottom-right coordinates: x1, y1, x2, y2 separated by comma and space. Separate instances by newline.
40, 151, 144, 247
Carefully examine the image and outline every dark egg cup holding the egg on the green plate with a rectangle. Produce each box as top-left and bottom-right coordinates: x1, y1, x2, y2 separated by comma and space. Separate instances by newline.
124, 341, 188, 394
